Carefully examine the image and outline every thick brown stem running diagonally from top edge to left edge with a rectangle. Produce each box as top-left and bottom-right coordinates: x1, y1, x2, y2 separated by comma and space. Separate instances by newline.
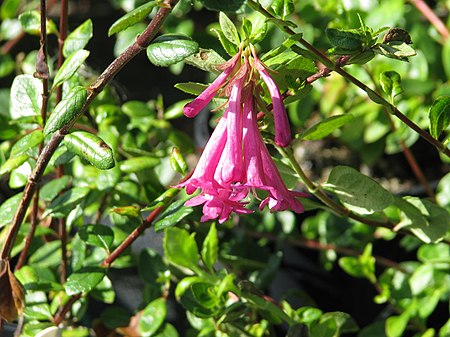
0, 0, 178, 259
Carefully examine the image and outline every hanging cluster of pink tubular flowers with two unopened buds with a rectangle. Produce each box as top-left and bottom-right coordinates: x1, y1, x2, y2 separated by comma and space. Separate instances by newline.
178, 46, 305, 223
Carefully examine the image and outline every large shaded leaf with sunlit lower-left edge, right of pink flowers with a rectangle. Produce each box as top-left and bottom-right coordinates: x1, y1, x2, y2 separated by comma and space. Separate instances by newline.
324, 166, 394, 214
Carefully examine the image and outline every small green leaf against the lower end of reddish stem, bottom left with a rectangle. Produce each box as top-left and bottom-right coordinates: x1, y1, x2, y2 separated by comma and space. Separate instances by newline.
64, 267, 105, 296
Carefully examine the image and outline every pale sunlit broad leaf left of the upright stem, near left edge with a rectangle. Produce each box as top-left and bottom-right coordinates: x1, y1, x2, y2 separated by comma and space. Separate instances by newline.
10, 75, 42, 119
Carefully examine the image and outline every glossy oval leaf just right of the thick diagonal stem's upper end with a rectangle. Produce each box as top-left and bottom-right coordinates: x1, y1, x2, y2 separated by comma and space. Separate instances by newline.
147, 34, 198, 67
